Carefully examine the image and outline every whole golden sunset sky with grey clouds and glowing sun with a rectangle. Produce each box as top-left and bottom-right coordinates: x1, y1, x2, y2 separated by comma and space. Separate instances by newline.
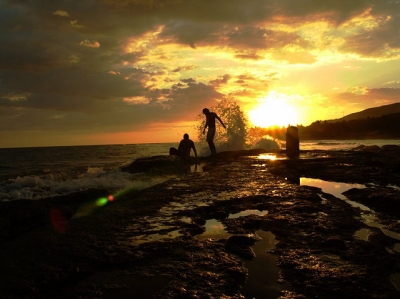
0, 0, 400, 147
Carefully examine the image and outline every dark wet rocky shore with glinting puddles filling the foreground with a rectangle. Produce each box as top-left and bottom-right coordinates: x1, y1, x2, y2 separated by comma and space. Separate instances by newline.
0, 147, 400, 299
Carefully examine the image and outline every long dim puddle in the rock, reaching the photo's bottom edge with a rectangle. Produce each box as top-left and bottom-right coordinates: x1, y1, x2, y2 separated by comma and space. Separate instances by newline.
242, 230, 287, 299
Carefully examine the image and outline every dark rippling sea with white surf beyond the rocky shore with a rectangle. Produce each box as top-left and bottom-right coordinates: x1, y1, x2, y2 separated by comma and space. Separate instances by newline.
0, 139, 400, 201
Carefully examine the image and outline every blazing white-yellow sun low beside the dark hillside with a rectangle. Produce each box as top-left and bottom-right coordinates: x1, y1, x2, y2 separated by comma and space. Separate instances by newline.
247, 91, 297, 128
